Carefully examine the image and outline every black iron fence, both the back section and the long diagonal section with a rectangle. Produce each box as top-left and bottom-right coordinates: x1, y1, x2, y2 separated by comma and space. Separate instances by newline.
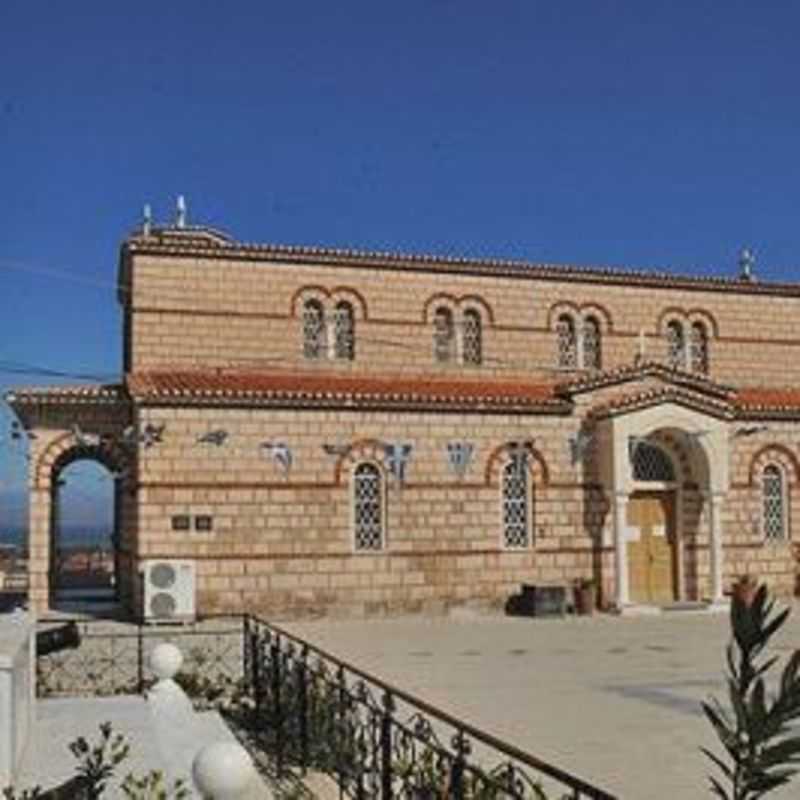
37, 615, 614, 800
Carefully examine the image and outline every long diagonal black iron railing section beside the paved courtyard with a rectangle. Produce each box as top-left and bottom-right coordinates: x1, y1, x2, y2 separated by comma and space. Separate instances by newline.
244, 617, 612, 800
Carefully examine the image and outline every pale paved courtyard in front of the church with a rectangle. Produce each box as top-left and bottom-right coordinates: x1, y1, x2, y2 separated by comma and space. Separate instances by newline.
286, 608, 800, 800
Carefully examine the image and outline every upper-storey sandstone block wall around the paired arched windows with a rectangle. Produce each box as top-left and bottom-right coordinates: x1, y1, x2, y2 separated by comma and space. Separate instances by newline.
130, 255, 800, 386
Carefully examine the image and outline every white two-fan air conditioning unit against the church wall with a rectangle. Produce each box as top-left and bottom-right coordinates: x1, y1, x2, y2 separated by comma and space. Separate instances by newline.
142, 559, 195, 622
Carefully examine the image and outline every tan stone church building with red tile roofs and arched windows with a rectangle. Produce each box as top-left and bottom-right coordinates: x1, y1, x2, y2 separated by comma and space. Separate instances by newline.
7, 220, 800, 616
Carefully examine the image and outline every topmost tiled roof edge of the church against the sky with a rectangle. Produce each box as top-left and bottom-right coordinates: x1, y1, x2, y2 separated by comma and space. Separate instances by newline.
122, 227, 800, 296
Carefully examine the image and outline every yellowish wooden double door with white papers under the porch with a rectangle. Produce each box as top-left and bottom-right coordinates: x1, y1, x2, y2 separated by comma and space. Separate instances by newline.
627, 492, 677, 605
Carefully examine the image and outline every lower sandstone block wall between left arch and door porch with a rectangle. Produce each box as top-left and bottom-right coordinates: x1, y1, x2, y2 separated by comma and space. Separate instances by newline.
133, 408, 611, 614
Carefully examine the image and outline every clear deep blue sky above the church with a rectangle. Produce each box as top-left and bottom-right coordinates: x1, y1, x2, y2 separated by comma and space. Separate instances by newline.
0, 0, 800, 532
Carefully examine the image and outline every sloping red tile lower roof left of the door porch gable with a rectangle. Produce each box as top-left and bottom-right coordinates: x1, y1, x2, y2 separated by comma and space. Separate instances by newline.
127, 371, 570, 411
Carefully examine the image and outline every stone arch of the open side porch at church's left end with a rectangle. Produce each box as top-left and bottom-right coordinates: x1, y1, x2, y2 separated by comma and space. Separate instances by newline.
28, 429, 135, 613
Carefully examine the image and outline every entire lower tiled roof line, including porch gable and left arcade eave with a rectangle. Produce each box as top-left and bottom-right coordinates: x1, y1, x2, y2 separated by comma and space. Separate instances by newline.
12, 364, 800, 419
